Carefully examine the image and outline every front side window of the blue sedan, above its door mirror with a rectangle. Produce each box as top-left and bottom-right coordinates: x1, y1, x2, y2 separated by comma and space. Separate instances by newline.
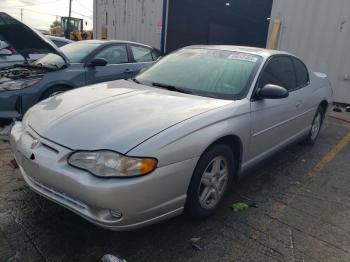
94, 45, 129, 64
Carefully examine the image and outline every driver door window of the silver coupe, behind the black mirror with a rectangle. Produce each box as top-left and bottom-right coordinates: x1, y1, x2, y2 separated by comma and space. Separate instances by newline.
259, 56, 297, 91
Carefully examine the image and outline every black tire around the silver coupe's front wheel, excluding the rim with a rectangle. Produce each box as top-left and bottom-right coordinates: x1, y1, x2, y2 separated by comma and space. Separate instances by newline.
185, 144, 236, 219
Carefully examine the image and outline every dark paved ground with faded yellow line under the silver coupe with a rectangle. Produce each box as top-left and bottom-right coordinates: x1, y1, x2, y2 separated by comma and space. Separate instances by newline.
0, 119, 350, 262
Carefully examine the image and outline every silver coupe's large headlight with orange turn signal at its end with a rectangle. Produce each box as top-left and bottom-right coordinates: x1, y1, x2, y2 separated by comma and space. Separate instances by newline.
68, 150, 157, 178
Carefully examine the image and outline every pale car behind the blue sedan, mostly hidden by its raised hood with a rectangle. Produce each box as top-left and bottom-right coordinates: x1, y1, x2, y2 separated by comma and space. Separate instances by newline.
0, 35, 73, 68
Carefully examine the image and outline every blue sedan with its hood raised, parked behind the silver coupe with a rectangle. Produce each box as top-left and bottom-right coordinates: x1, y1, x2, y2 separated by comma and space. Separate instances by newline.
0, 13, 161, 123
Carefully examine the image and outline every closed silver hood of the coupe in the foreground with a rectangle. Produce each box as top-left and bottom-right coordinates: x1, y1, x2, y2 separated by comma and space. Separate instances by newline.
23, 80, 232, 154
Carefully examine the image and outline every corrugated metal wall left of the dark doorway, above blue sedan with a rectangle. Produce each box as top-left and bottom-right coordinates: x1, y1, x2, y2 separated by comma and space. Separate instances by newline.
94, 0, 163, 49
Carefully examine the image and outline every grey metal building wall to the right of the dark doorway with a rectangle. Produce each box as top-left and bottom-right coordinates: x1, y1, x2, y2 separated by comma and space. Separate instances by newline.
270, 0, 350, 103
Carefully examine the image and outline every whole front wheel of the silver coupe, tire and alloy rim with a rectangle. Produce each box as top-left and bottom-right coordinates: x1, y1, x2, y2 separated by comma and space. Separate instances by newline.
185, 144, 237, 220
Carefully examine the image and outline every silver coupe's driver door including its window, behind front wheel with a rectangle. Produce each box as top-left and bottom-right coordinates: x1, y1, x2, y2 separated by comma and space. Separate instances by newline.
249, 55, 303, 161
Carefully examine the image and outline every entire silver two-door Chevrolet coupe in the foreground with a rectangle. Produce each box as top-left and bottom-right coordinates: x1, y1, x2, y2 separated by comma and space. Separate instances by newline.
11, 46, 333, 230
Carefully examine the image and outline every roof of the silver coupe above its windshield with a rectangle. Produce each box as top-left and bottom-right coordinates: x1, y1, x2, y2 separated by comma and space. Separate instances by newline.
185, 45, 293, 58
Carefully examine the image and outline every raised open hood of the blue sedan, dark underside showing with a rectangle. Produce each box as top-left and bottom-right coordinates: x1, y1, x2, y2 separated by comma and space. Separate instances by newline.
0, 12, 68, 63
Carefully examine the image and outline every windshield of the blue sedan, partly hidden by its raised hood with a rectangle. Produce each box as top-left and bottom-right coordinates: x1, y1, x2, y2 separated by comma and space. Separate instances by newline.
34, 42, 100, 68
